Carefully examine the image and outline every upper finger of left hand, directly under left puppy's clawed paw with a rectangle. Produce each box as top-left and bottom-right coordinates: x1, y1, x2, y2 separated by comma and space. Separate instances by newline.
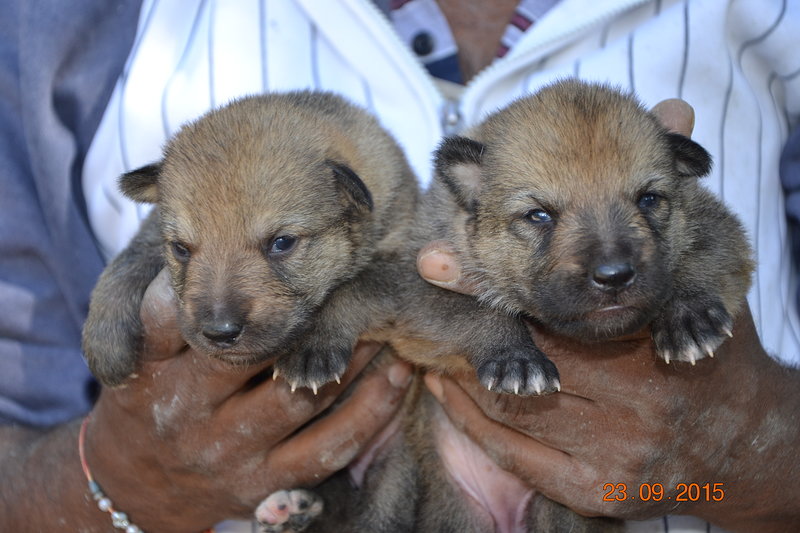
224, 342, 390, 442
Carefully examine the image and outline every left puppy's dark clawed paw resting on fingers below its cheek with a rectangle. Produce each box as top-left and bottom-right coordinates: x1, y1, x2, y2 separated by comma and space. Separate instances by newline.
275, 346, 352, 394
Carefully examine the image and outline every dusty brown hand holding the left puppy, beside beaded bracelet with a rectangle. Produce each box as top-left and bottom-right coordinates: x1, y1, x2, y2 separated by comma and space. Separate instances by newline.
86, 271, 411, 532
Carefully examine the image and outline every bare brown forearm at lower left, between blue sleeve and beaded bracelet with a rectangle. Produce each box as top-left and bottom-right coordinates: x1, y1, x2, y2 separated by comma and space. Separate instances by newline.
0, 421, 112, 533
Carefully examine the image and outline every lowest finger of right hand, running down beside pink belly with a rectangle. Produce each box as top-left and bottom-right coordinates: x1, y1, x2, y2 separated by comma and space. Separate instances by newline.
424, 374, 572, 484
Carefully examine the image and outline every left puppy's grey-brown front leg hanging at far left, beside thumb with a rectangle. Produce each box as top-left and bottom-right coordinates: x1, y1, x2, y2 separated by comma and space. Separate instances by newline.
83, 209, 164, 386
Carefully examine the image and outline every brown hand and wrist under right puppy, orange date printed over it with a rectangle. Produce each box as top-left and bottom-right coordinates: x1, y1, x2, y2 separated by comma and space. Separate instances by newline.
425, 310, 800, 531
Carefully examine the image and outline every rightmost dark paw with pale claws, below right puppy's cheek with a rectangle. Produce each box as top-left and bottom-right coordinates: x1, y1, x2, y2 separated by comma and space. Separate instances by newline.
651, 300, 733, 364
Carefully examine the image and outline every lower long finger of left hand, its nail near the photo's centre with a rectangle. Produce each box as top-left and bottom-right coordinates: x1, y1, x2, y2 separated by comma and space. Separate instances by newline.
271, 361, 412, 486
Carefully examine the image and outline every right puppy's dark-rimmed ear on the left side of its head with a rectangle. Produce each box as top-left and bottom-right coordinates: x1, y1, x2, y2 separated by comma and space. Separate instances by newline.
434, 137, 483, 213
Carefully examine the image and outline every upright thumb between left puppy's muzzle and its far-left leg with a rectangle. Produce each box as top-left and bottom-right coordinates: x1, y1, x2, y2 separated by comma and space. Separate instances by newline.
139, 268, 186, 360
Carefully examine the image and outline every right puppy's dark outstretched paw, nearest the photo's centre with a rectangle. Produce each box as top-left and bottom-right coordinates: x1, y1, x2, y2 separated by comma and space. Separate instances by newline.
478, 353, 561, 396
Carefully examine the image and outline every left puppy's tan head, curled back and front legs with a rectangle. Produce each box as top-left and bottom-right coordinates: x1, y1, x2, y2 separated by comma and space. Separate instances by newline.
83, 92, 417, 390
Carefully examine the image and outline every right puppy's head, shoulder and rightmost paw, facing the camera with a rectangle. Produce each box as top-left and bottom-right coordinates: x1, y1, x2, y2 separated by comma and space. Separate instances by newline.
434, 80, 753, 364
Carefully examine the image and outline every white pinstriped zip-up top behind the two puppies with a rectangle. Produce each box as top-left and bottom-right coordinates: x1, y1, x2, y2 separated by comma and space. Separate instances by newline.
83, 0, 800, 532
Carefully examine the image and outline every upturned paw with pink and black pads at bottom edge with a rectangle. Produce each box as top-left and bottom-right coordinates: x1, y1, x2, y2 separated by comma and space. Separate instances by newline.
255, 489, 323, 533
